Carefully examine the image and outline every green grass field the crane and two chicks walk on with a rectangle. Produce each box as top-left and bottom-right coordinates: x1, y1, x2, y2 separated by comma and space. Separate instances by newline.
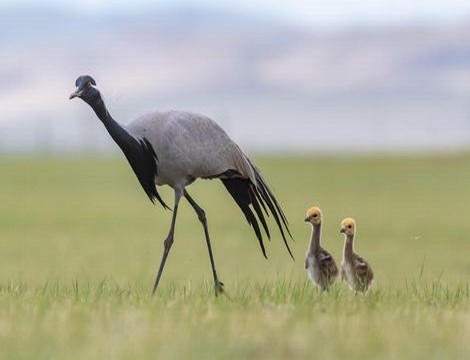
0, 155, 470, 360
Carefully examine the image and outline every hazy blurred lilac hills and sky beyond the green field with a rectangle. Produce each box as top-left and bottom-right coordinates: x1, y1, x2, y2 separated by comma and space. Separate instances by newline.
0, 0, 470, 154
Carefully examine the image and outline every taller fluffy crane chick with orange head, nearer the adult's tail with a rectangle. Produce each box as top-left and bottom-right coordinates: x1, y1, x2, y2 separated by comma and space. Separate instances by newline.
305, 206, 338, 291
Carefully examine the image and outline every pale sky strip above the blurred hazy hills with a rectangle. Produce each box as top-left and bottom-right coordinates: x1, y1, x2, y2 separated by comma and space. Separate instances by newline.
0, 0, 470, 27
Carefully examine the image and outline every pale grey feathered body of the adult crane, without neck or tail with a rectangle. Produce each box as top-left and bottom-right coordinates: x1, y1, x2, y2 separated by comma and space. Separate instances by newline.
126, 111, 256, 188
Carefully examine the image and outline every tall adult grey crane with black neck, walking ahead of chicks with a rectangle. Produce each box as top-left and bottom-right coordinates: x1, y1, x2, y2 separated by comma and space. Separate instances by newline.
70, 75, 293, 295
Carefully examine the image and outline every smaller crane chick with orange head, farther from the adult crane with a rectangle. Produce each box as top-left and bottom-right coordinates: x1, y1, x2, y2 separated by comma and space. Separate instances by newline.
340, 218, 374, 292
